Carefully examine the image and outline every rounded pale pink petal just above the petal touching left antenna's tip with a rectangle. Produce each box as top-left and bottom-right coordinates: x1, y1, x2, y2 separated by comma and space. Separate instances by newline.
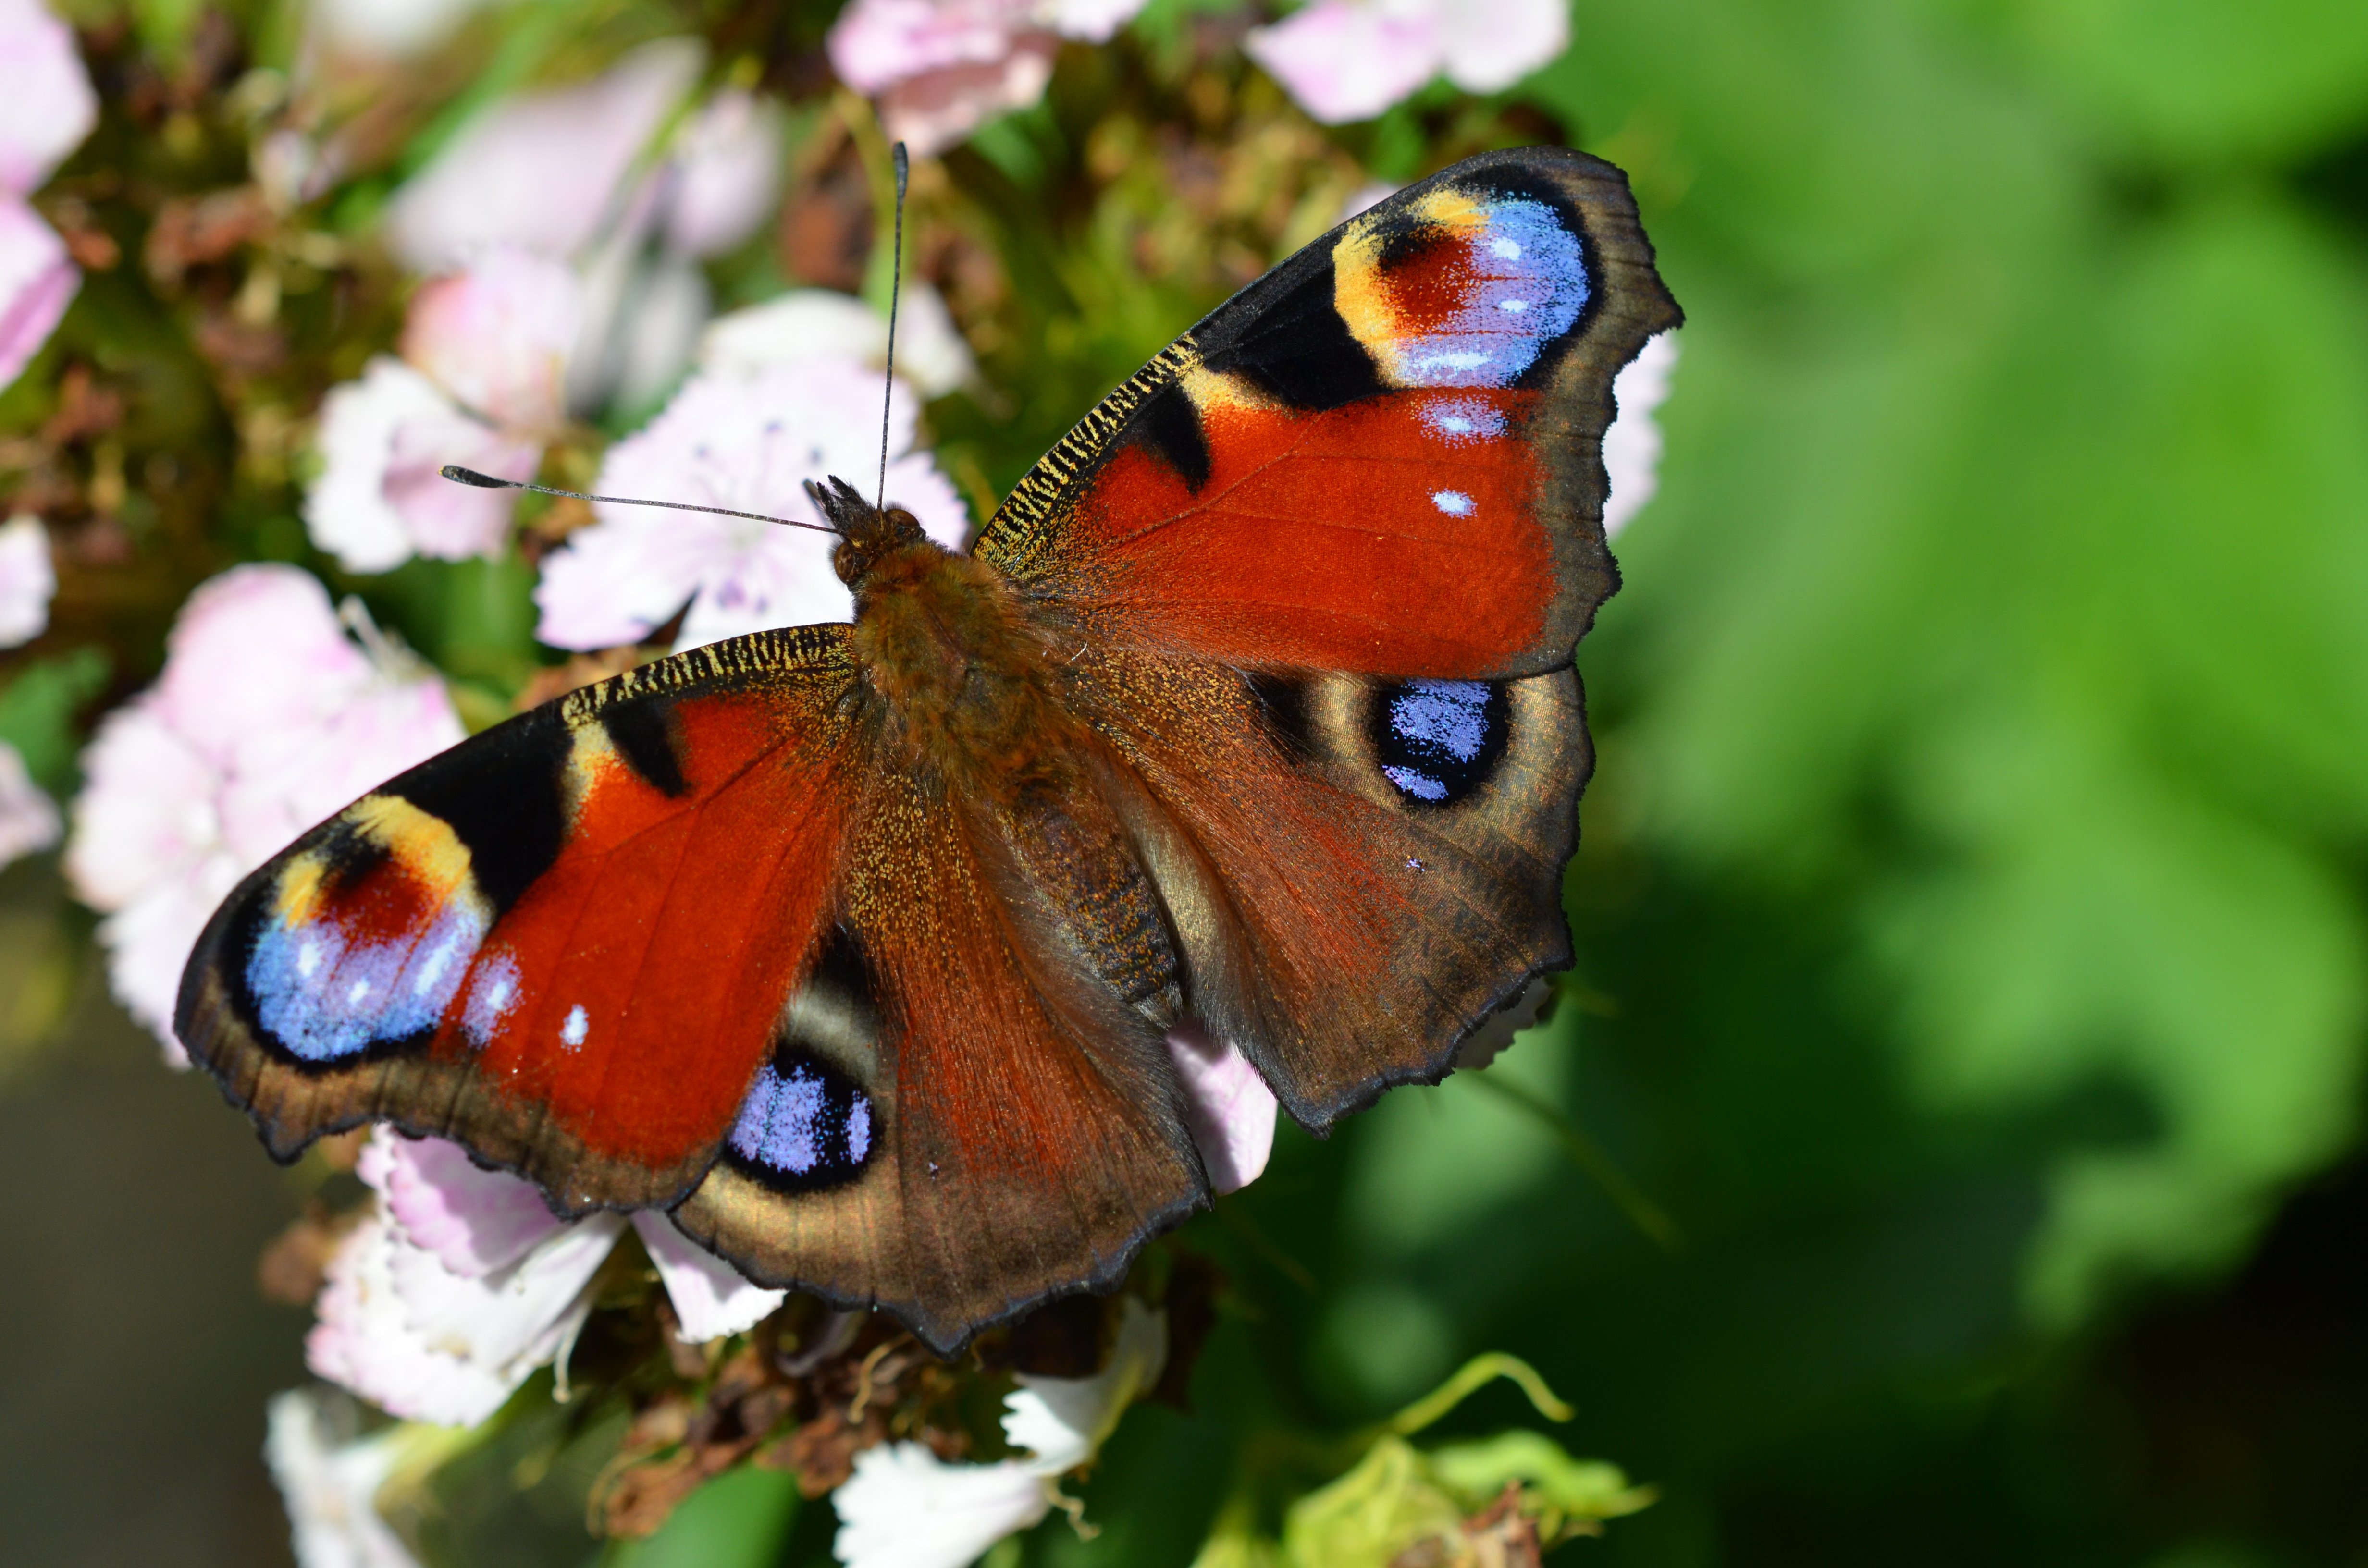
403, 244, 582, 431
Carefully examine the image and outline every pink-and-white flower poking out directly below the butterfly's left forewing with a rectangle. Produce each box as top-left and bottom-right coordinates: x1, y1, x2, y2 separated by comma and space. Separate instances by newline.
306, 1127, 784, 1426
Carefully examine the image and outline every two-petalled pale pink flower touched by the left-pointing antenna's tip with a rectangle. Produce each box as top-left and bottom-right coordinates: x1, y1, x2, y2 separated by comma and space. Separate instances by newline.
303, 249, 580, 571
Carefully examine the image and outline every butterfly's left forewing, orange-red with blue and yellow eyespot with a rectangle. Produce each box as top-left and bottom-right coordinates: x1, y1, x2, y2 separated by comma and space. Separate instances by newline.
175, 628, 862, 1210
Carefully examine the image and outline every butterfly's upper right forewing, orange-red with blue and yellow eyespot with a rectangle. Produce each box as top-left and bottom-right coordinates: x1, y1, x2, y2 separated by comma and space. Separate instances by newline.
978, 147, 1679, 677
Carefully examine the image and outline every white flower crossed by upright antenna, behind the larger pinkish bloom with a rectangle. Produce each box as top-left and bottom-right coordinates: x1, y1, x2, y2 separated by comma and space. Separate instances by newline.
699, 280, 978, 398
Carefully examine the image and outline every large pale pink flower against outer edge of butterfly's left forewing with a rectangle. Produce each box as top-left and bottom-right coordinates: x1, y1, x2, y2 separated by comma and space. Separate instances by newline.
66, 566, 462, 1066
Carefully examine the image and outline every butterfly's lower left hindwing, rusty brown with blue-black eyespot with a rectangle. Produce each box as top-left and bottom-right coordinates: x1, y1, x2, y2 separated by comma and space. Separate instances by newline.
675, 774, 1208, 1352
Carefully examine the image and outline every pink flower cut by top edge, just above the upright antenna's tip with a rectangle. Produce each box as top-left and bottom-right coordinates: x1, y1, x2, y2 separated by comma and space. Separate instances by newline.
829, 0, 1144, 156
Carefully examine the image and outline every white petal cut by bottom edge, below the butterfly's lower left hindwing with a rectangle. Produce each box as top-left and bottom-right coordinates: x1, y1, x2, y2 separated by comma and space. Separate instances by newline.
831, 1443, 1051, 1568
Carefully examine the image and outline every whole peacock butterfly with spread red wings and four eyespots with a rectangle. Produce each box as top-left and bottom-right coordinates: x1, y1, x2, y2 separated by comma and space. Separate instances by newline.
175, 147, 1679, 1352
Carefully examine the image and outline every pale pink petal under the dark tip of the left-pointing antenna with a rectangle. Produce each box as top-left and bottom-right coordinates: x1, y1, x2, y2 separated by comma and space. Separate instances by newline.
303, 358, 543, 571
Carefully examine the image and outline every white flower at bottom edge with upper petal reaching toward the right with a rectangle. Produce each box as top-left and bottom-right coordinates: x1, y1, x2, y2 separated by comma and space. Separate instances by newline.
831, 1296, 1168, 1568
